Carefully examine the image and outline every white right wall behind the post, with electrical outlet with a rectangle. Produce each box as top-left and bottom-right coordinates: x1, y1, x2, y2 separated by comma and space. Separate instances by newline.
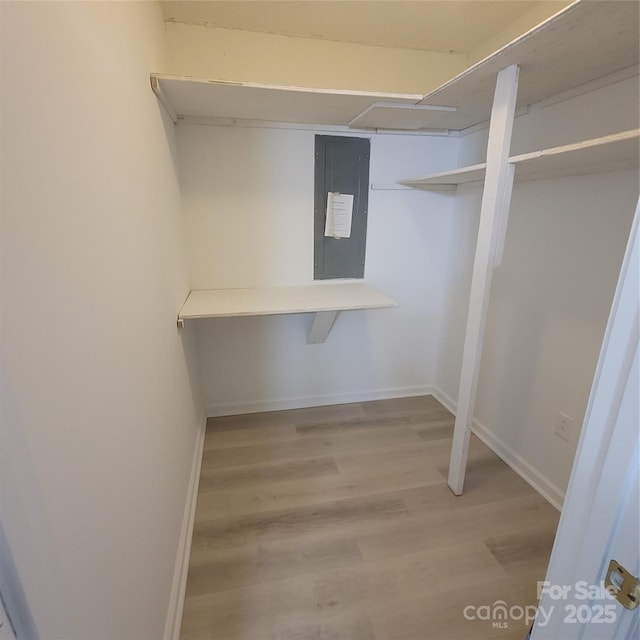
437, 79, 638, 502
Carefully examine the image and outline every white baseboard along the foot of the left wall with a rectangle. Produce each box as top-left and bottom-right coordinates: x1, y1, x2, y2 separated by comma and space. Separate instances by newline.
164, 418, 207, 640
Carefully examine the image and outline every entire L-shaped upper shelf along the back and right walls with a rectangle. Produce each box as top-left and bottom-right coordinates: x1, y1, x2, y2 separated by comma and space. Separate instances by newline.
151, 0, 640, 131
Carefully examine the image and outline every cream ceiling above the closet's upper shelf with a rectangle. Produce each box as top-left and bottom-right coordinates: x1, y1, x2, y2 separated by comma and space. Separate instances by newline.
161, 0, 566, 55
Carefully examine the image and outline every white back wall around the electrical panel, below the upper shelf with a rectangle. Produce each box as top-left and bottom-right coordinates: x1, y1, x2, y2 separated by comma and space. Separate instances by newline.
178, 124, 459, 414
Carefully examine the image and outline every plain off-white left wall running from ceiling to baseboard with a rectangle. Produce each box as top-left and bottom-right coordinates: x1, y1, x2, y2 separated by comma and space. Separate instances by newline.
0, 2, 201, 640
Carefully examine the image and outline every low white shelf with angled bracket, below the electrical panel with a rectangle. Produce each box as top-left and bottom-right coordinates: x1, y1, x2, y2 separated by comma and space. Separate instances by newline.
178, 283, 398, 344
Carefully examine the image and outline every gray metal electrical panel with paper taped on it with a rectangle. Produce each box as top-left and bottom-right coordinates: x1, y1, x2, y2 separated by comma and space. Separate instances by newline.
314, 135, 370, 280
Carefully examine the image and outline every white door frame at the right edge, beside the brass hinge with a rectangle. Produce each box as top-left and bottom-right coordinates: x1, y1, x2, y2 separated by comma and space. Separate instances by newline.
532, 200, 640, 640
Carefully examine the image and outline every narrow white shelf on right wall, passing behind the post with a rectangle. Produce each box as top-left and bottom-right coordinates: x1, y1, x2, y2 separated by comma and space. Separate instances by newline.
398, 129, 640, 190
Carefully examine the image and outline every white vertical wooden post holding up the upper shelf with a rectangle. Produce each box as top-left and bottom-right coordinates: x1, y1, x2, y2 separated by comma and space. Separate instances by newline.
448, 65, 518, 495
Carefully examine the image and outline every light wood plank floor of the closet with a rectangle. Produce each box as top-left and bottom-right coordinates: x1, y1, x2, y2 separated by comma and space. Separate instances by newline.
181, 396, 559, 640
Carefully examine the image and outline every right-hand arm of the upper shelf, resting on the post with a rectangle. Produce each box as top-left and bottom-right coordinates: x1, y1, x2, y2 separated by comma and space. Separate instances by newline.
420, 0, 640, 130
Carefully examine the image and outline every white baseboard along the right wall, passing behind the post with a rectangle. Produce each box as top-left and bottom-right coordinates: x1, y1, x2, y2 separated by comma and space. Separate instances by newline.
432, 386, 564, 511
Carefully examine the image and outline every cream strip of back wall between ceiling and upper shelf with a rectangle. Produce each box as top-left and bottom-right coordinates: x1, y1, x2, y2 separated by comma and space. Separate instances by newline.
162, 22, 468, 93
